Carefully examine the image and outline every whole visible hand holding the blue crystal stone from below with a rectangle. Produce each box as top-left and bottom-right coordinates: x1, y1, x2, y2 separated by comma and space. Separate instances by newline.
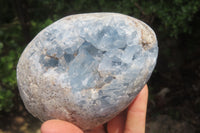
41, 85, 148, 133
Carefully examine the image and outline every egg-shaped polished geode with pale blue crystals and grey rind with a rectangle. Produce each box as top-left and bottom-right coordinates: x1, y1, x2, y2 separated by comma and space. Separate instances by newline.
17, 13, 158, 130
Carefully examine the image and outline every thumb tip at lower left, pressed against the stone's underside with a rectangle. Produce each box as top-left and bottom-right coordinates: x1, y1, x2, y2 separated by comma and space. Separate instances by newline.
41, 120, 83, 133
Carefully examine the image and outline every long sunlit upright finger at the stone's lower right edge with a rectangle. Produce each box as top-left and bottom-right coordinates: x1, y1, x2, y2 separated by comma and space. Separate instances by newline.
124, 85, 148, 133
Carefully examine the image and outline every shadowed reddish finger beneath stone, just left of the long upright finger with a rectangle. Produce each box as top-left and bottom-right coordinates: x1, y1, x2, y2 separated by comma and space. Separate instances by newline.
107, 112, 126, 133
